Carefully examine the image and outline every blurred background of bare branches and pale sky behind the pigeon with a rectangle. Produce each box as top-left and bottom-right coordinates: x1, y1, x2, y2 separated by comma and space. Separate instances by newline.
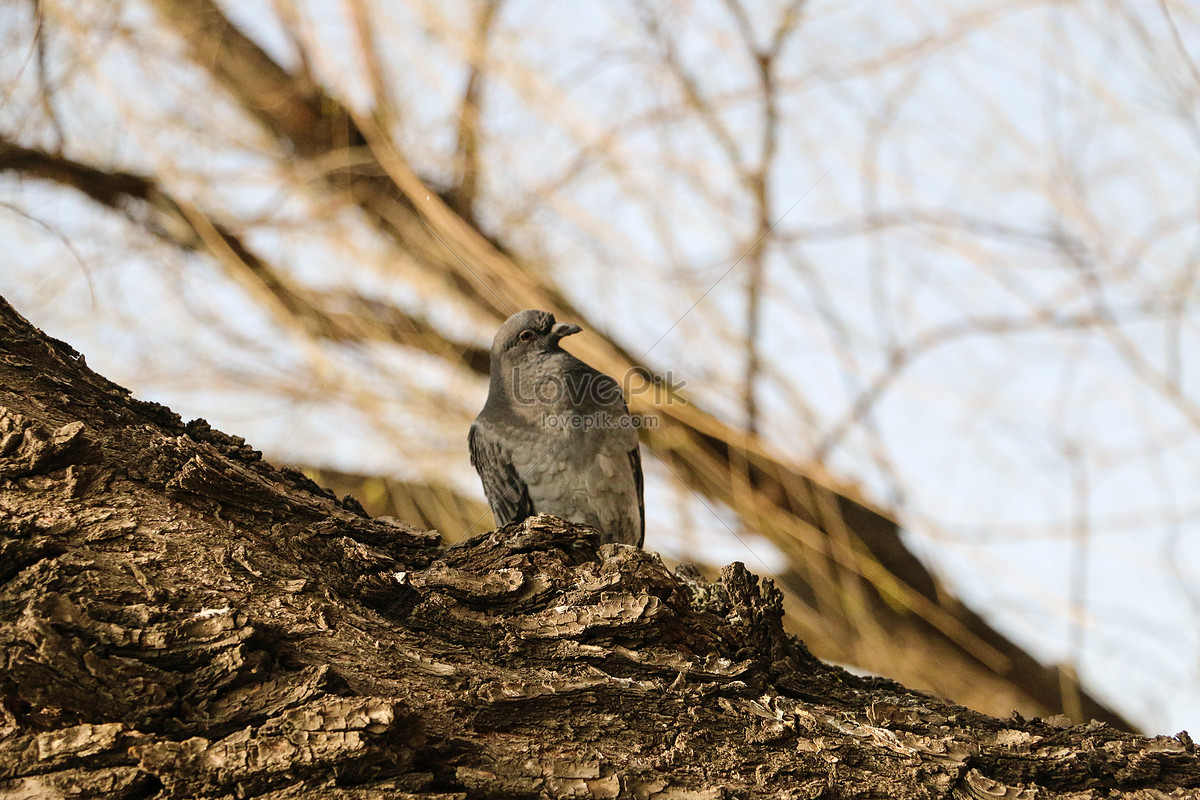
0, 0, 1200, 733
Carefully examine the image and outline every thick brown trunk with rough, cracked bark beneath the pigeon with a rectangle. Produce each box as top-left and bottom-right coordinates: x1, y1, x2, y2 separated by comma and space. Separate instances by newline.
0, 300, 1200, 800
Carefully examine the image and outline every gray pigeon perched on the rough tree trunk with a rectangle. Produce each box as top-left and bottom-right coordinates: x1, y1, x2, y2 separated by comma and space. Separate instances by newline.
468, 311, 646, 547
